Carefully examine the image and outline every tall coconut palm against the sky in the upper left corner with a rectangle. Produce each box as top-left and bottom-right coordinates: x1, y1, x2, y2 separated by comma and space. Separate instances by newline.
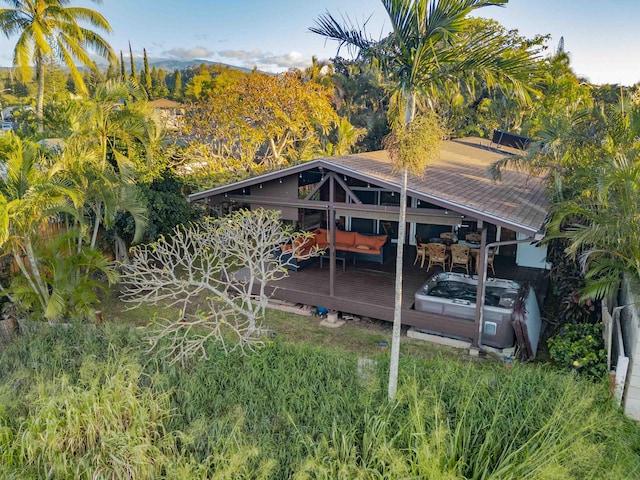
0, 0, 116, 132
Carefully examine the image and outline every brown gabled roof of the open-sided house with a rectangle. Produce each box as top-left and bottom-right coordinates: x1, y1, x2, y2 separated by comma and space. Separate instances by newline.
189, 138, 549, 234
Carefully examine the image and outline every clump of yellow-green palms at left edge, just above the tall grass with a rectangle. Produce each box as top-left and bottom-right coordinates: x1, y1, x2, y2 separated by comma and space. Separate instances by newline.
0, 134, 115, 320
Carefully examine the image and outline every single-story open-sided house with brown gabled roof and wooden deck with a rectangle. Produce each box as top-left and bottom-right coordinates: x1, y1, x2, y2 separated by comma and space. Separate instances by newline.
189, 138, 549, 350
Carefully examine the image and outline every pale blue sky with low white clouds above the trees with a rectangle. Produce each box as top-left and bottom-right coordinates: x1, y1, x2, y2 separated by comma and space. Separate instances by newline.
0, 0, 640, 85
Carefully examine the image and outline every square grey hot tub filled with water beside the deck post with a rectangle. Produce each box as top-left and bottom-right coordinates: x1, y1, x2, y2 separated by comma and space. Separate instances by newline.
414, 272, 520, 348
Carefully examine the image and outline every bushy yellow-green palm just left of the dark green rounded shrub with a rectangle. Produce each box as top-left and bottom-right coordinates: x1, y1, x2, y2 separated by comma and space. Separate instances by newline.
65, 80, 162, 255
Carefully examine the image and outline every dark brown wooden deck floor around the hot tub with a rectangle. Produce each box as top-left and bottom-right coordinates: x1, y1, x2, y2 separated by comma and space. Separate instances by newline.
273, 247, 547, 340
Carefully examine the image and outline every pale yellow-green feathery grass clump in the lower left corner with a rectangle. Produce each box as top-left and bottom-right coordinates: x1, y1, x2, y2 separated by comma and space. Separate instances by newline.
0, 350, 274, 479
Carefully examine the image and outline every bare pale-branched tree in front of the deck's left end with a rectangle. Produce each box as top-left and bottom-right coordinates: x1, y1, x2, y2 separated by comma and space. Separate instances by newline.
122, 209, 317, 363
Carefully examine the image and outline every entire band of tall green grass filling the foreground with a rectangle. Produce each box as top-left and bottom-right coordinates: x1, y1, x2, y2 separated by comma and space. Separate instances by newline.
0, 327, 640, 480
